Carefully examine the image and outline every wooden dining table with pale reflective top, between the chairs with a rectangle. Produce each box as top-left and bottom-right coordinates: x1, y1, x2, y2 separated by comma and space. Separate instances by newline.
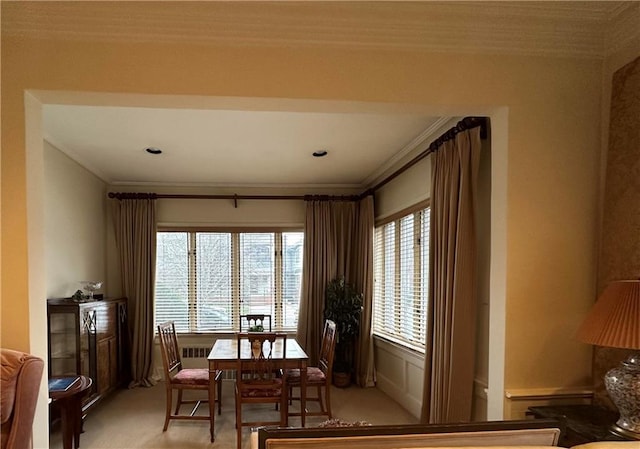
207, 337, 309, 443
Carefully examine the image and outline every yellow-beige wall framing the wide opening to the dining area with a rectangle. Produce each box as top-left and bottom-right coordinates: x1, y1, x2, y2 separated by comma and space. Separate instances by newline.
1, 20, 602, 438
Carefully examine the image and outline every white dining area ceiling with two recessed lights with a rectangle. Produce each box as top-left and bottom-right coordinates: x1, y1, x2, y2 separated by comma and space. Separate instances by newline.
43, 105, 446, 188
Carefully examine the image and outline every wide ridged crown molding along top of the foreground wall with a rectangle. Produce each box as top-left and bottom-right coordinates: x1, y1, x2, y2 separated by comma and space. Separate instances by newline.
2, 1, 638, 58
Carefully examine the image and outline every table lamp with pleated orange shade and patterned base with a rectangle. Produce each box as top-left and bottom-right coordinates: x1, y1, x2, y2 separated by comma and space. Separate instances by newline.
577, 280, 640, 440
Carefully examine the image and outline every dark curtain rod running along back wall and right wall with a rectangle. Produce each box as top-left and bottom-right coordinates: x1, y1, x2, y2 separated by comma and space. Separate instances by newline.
109, 117, 487, 201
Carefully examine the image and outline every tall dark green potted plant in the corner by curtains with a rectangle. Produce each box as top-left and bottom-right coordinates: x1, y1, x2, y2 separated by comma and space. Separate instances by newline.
324, 277, 362, 387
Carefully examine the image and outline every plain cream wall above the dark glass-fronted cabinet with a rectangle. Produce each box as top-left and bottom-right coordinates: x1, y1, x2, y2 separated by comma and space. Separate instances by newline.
44, 141, 109, 298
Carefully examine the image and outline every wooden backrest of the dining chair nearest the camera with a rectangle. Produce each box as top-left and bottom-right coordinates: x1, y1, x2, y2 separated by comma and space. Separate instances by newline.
236, 332, 287, 383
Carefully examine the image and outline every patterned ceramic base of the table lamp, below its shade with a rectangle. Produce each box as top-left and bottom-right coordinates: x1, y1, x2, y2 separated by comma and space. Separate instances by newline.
604, 353, 640, 440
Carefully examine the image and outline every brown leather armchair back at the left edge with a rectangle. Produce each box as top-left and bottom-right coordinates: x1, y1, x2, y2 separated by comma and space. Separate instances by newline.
0, 348, 44, 449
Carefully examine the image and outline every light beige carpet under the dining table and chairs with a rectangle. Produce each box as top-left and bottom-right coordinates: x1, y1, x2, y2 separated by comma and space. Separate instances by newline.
49, 381, 417, 449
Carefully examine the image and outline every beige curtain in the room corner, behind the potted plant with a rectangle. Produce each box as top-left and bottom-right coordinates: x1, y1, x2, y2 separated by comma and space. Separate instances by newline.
297, 197, 373, 378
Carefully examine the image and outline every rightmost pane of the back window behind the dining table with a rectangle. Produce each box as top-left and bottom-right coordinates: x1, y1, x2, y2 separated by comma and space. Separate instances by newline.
282, 232, 304, 329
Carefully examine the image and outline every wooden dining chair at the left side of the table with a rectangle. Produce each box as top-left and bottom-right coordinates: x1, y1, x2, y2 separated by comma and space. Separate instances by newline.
158, 321, 222, 432
